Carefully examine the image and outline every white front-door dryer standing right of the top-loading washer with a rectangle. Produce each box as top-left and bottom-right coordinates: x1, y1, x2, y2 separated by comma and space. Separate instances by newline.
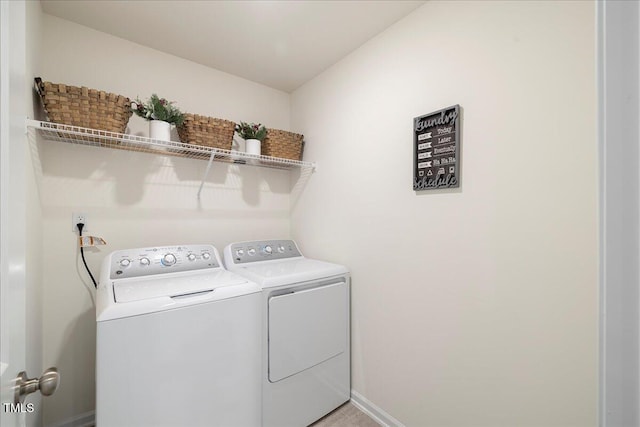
224, 240, 351, 427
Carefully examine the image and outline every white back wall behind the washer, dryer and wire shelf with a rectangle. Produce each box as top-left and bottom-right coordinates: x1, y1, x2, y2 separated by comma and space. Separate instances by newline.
36, 14, 290, 425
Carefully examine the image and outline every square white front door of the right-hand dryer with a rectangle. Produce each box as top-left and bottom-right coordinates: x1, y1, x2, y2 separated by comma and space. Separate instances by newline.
269, 280, 349, 382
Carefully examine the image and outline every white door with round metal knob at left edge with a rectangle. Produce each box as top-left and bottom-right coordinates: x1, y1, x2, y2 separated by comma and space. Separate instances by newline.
0, 0, 29, 427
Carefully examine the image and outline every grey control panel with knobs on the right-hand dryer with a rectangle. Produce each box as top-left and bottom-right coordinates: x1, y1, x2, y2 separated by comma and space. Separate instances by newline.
225, 240, 302, 264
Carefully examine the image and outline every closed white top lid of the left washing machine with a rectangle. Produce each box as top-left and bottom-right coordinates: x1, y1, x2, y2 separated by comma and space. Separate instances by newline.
113, 269, 247, 303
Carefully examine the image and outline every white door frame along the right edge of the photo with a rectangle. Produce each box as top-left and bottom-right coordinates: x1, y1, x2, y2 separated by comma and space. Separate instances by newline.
595, 1, 640, 427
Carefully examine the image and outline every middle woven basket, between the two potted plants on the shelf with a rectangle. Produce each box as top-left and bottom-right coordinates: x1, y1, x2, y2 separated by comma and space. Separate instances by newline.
178, 113, 236, 150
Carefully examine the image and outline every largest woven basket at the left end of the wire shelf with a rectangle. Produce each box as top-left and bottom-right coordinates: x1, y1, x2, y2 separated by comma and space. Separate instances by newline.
35, 77, 132, 133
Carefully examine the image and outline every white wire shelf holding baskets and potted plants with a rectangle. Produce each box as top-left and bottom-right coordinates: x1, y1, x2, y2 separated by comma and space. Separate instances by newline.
26, 119, 316, 171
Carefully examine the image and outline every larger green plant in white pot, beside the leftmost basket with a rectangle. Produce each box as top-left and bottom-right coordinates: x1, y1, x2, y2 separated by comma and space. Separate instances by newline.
131, 93, 184, 141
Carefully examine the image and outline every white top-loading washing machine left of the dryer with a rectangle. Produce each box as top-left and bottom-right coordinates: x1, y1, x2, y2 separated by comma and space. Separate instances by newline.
96, 245, 262, 427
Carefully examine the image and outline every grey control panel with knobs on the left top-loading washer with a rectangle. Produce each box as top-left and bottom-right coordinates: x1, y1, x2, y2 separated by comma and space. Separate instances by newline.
109, 245, 220, 279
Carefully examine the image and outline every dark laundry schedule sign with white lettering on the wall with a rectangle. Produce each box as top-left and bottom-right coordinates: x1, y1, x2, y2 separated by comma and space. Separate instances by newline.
413, 105, 460, 191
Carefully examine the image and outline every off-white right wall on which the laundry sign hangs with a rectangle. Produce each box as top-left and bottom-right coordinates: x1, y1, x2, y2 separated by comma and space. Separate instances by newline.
291, 1, 598, 427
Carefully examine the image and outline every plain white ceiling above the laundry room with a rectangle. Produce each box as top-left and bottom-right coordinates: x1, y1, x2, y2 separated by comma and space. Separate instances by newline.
41, 0, 424, 92
